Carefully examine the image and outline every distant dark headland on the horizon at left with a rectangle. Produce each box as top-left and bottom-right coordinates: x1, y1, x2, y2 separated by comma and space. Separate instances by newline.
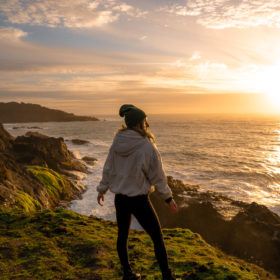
0, 102, 98, 123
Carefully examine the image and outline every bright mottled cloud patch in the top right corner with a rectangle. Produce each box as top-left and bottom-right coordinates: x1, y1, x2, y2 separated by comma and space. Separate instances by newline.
160, 0, 280, 29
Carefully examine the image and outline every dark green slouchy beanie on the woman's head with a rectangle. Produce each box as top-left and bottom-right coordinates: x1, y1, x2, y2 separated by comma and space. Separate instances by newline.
119, 104, 147, 127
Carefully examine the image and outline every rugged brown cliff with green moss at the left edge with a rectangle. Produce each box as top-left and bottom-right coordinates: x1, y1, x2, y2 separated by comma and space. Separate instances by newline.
0, 124, 87, 212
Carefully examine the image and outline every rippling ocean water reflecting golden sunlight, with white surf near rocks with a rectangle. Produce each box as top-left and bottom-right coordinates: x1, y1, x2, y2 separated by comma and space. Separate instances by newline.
4, 112, 280, 220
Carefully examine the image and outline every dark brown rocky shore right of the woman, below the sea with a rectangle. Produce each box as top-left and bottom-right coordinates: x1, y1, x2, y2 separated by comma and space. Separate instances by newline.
151, 176, 280, 276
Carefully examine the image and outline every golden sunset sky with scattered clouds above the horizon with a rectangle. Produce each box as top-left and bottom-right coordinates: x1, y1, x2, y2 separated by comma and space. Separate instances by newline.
0, 0, 280, 115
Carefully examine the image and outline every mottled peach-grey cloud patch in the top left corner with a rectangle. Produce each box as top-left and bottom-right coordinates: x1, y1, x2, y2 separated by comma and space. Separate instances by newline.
0, 0, 145, 28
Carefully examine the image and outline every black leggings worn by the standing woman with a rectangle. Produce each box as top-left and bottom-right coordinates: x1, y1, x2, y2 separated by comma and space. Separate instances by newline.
115, 194, 169, 272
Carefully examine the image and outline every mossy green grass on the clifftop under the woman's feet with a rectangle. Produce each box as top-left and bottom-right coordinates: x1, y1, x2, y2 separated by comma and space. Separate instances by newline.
0, 209, 276, 280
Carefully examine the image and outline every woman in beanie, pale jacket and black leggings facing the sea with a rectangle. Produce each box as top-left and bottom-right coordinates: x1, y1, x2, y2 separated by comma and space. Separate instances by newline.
97, 104, 178, 280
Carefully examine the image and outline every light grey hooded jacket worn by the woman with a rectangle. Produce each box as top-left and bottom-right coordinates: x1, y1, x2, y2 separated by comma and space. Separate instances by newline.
97, 129, 172, 200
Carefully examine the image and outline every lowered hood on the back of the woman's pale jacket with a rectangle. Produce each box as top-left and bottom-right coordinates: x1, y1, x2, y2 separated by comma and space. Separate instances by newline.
113, 129, 147, 157
